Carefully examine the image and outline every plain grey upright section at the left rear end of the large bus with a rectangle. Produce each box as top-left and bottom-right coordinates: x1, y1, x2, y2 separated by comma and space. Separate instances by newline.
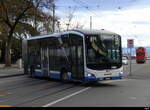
22, 40, 28, 74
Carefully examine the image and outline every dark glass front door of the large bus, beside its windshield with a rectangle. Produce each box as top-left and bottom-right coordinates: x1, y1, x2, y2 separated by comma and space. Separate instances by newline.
69, 34, 84, 79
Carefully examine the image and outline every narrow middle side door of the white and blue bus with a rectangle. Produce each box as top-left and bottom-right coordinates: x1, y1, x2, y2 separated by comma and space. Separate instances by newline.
41, 48, 49, 77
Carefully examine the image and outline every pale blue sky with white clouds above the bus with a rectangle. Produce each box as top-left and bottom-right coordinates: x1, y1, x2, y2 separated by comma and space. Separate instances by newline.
55, 0, 150, 47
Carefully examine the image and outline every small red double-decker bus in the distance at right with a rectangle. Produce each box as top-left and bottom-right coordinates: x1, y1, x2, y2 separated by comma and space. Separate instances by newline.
136, 47, 146, 63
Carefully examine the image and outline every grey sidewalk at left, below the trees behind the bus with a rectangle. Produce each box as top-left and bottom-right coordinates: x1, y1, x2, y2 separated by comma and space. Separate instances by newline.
0, 64, 24, 78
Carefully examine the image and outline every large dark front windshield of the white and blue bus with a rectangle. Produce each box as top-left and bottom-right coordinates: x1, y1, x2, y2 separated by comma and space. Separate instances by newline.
85, 35, 122, 70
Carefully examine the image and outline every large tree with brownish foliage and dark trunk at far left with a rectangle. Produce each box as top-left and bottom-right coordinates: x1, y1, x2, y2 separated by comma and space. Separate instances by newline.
0, 0, 53, 67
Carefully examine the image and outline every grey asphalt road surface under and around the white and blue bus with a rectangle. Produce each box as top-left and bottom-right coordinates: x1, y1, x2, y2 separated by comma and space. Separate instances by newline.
0, 61, 150, 107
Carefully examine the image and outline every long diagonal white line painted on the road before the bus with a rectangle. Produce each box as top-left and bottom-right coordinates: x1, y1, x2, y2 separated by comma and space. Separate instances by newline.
42, 87, 91, 107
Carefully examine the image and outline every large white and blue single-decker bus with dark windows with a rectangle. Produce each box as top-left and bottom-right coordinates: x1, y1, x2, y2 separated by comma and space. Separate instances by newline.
23, 29, 124, 82
